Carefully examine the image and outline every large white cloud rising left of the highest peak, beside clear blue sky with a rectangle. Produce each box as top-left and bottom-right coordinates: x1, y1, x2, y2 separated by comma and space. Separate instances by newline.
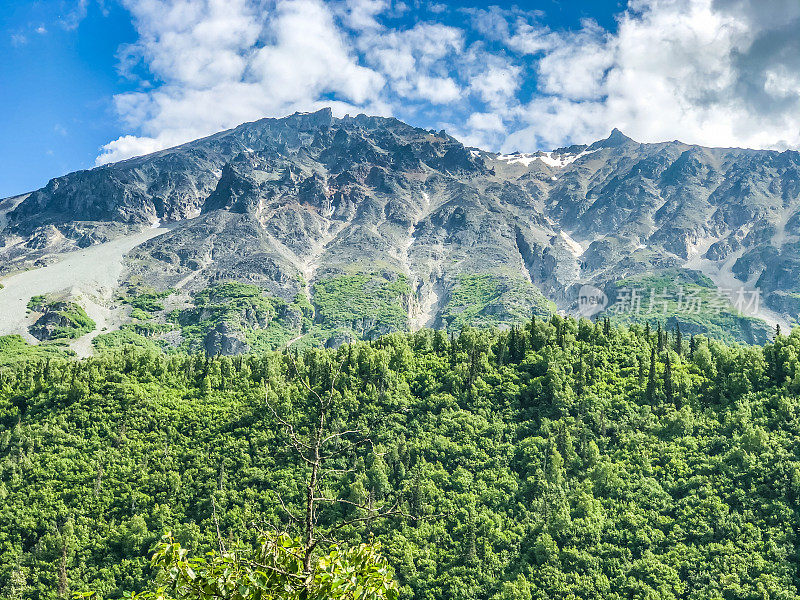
97, 0, 385, 164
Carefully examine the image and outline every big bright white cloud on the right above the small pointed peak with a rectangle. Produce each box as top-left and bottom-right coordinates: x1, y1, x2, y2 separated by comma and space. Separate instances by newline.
504, 0, 800, 149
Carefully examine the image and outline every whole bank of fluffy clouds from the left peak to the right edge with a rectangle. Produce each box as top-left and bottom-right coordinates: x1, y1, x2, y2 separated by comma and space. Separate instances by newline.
98, 0, 800, 163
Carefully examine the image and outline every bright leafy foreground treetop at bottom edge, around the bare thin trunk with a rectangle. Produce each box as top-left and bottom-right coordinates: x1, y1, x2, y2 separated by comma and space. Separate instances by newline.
77, 534, 397, 600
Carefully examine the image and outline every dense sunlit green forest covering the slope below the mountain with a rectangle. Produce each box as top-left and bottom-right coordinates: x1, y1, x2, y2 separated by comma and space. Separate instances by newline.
0, 316, 800, 600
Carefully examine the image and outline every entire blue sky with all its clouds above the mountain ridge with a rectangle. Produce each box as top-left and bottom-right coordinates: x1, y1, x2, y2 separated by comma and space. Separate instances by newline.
0, 0, 800, 197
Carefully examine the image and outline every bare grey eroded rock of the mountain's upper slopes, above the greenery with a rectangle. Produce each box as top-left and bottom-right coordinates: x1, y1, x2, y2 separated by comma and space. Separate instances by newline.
6, 105, 800, 344
